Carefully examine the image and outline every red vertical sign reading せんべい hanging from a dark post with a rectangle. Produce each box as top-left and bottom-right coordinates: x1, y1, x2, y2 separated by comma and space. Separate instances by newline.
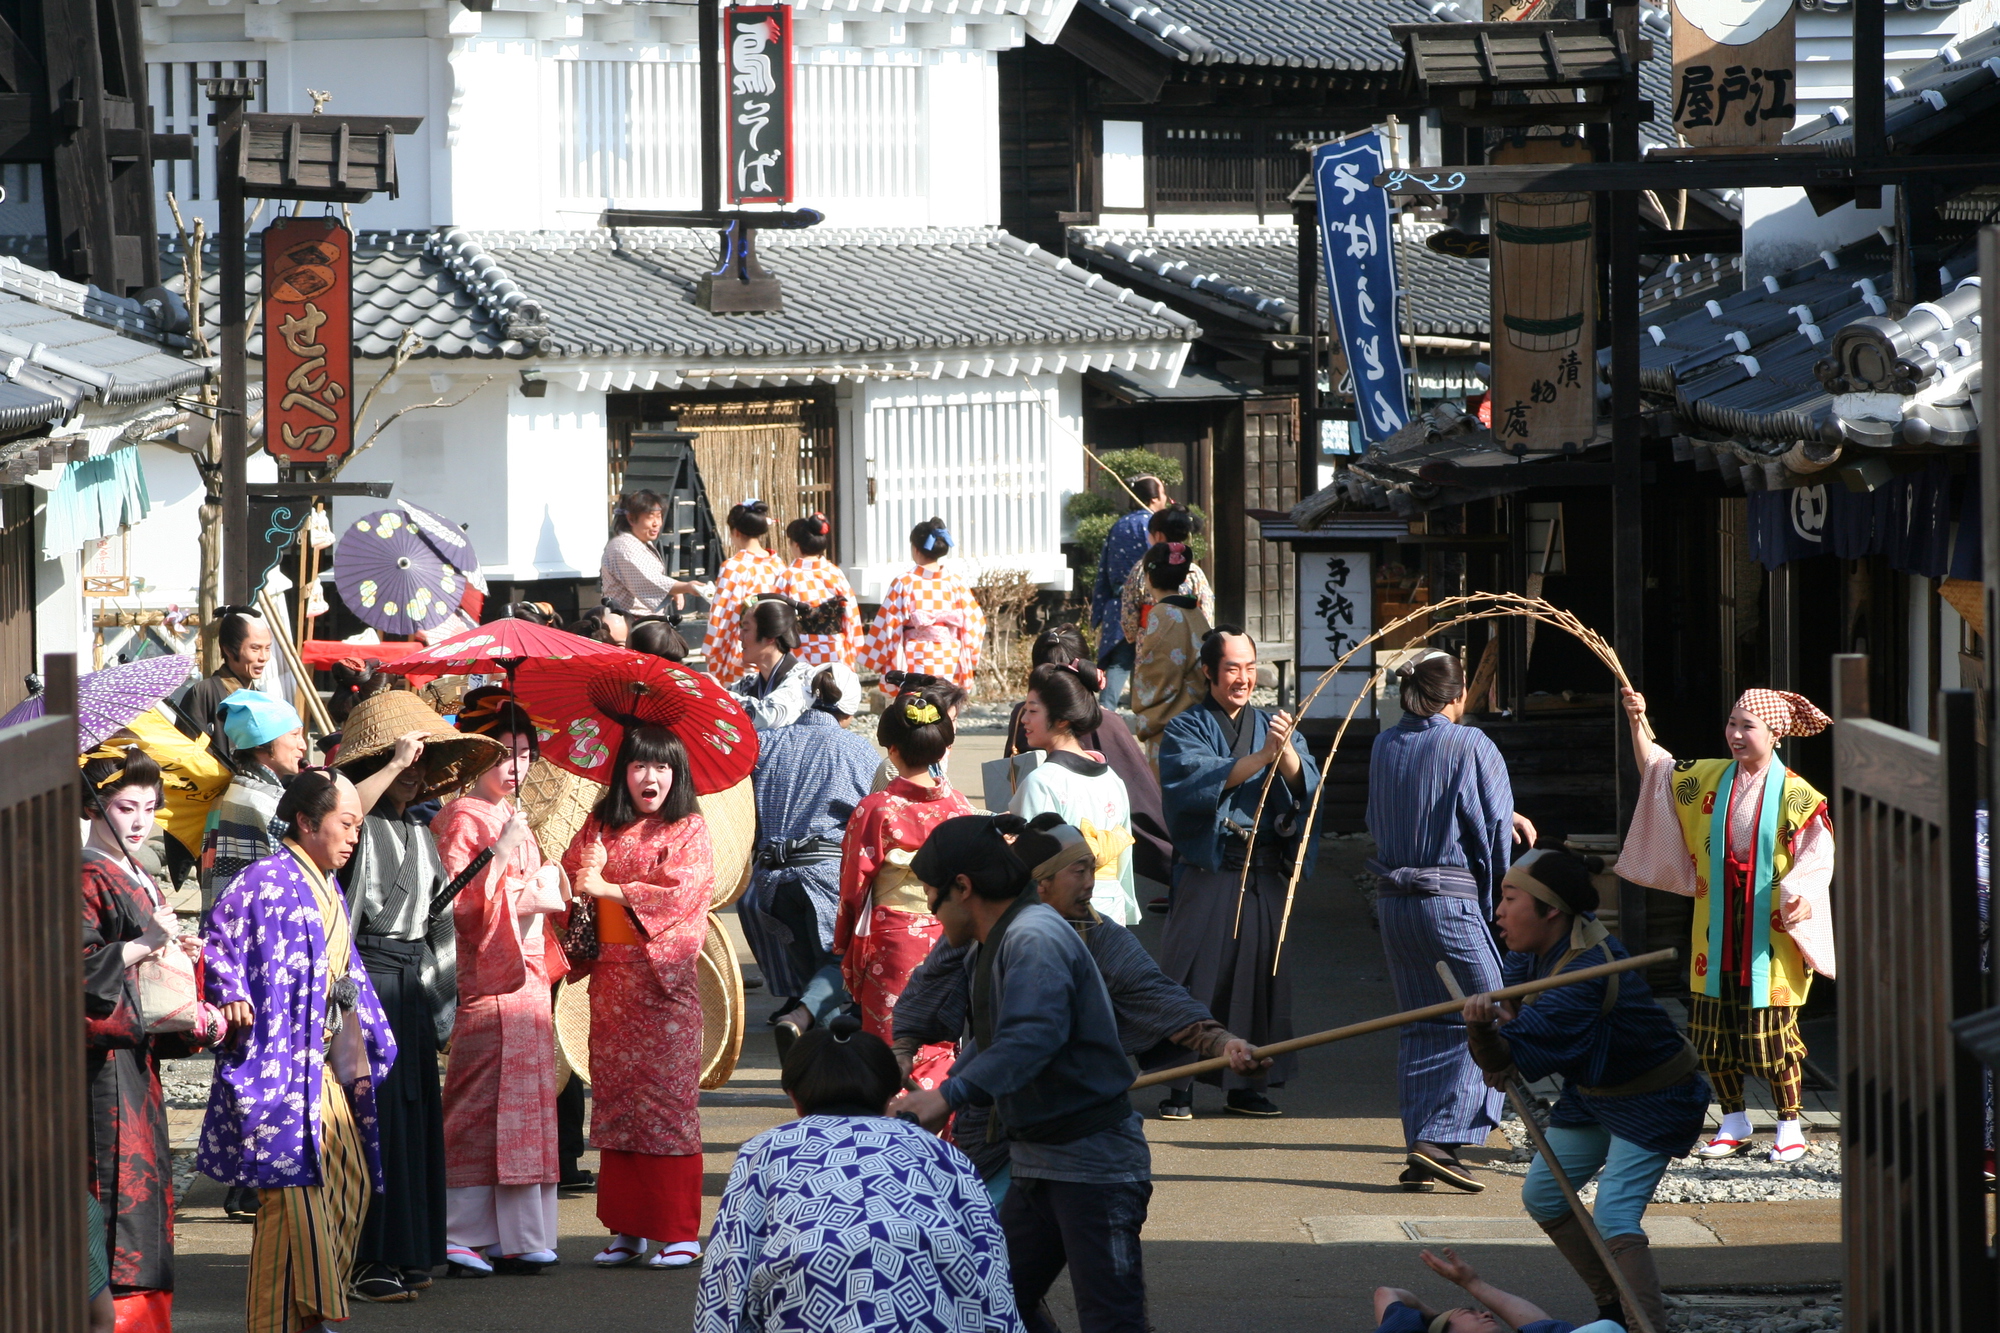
264, 216, 354, 464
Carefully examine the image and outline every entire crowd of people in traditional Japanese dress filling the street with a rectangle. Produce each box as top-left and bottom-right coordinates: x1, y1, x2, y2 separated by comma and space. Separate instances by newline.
66, 478, 1834, 1333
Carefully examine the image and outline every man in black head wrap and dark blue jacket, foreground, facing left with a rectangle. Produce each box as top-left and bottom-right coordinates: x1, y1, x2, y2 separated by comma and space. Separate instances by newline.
890, 815, 1152, 1333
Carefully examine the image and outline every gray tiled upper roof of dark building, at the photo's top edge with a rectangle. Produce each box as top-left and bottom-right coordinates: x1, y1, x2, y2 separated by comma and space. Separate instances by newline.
1078, 0, 1478, 74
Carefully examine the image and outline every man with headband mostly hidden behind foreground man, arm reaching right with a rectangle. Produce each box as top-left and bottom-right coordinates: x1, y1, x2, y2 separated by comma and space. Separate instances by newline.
890, 815, 1258, 1205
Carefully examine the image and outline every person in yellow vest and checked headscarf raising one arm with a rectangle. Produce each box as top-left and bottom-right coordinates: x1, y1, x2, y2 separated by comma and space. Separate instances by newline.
1618, 689, 1836, 1163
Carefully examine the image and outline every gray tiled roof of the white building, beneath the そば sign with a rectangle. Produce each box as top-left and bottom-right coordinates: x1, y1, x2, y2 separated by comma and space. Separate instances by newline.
184, 228, 1198, 358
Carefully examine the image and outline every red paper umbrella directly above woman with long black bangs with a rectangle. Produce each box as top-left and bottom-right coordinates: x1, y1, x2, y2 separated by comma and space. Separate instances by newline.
516, 648, 756, 795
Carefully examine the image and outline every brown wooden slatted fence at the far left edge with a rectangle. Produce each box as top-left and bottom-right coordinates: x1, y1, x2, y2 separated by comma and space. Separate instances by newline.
0, 656, 90, 1333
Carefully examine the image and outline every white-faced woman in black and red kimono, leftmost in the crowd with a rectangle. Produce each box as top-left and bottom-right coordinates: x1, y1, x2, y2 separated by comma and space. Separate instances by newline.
82, 751, 222, 1333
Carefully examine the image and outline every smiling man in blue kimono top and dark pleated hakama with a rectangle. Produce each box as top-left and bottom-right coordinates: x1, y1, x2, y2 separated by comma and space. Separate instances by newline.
1160, 624, 1320, 1119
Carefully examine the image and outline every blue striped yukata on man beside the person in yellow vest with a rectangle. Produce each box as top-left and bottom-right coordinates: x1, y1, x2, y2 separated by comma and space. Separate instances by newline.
1368, 715, 1514, 1147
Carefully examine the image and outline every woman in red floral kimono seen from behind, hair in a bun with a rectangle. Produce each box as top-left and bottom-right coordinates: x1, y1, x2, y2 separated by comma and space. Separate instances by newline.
834, 691, 974, 1087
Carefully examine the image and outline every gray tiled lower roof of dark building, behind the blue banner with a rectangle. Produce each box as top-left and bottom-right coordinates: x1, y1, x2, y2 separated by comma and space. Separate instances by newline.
1070, 222, 1490, 338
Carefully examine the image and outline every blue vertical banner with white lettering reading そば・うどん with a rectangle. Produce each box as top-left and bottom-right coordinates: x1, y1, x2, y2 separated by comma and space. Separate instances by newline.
1312, 130, 1410, 452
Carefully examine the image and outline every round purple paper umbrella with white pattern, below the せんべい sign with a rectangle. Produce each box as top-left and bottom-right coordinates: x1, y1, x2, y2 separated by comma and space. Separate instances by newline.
334, 506, 478, 634
